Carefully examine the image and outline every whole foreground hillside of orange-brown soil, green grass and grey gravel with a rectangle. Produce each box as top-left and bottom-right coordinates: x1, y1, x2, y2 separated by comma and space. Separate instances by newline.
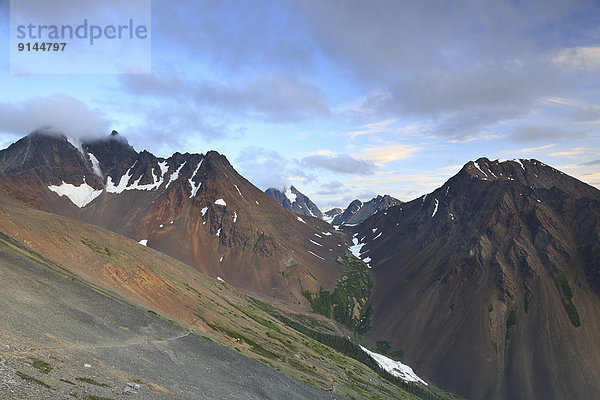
0, 188, 432, 399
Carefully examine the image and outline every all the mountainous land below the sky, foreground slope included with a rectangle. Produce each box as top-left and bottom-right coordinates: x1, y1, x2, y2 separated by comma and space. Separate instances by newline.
0, 131, 600, 399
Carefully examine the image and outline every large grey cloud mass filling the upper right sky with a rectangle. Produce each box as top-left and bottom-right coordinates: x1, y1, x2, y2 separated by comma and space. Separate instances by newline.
292, 0, 599, 139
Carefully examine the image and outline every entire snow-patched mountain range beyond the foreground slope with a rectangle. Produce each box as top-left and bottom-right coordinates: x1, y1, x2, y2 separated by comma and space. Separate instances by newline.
0, 131, 600, 399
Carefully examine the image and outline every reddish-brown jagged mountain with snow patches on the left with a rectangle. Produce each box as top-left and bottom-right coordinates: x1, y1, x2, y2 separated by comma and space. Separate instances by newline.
0, 132, 346, 304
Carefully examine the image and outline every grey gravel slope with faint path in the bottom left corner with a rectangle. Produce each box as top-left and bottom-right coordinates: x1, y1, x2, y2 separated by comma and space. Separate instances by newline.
0, 241, 340, 400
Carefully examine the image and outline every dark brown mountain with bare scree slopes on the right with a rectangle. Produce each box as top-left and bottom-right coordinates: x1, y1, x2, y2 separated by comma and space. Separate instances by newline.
355, 158, 600, 399
